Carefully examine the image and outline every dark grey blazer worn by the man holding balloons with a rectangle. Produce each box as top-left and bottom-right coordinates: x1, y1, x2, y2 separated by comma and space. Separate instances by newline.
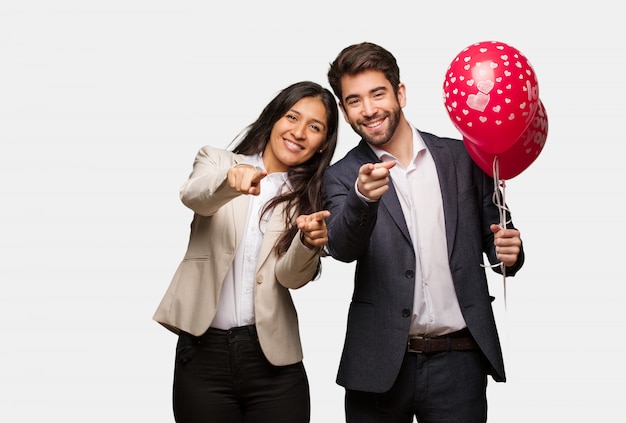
323, 132, 524, 392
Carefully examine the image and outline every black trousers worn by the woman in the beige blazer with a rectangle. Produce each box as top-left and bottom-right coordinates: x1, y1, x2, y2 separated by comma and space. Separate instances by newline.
173, 326, 311, 423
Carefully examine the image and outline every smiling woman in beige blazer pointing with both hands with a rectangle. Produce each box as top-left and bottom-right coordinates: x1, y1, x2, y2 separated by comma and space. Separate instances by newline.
154, 81, 338, 423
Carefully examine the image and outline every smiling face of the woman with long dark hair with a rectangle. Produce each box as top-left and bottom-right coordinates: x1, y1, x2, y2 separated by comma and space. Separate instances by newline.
263, 97, 328, 173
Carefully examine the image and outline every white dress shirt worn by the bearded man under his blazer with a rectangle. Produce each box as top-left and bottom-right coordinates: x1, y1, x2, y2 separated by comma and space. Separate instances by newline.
370, 126, 466, 336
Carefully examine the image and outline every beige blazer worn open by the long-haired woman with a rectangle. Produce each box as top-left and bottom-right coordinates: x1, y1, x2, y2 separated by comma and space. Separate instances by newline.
153, 146, 321, 365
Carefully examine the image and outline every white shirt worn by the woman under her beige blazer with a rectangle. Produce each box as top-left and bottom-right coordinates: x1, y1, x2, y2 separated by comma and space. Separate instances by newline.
211, 156, 288, 329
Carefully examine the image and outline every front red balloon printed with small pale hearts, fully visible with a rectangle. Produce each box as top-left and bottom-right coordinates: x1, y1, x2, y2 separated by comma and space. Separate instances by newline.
443, 41, 539, 154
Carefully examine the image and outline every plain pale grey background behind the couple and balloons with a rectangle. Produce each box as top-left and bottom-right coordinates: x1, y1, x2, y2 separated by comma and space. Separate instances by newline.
0, 0, 626, 423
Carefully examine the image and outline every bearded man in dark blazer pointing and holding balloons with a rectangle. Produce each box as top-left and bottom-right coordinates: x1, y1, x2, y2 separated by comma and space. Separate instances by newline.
323, 43, 524, 423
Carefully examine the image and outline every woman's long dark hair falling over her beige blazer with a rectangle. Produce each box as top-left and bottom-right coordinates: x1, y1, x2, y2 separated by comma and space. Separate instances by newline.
233, 81, 339, 255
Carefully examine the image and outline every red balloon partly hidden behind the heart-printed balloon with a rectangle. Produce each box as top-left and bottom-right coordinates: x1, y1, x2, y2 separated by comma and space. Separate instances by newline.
463, 101, 548, 180
